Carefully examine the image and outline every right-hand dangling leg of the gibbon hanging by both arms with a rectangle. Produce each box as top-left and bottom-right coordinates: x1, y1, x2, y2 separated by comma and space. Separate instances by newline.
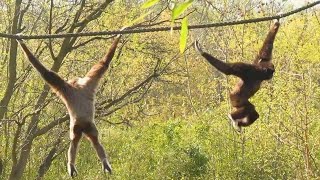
83, 123, 112, 173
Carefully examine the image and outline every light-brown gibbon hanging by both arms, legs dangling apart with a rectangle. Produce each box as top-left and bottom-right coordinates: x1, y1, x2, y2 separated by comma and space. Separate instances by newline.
18, 35, 120, 177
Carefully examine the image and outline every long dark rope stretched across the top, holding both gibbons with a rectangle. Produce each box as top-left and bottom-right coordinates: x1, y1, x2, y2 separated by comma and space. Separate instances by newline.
0, 0, 320, 39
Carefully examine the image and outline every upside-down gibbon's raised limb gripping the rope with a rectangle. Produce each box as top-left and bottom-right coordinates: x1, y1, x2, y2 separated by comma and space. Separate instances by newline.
255, 20, 280, 61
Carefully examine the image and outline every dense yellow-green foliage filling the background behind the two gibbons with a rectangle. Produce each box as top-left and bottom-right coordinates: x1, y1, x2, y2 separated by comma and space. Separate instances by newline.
0, 0, 320, 179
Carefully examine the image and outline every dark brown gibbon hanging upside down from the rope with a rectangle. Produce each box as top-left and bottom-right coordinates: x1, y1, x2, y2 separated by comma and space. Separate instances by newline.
195, 20, 280, 131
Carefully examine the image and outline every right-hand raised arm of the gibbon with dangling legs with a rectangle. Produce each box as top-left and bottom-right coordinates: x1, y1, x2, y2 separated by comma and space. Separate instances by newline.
86, 35, 121, 81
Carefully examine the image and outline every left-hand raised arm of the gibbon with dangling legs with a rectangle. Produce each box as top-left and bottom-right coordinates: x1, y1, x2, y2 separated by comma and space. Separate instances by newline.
17, 39, 66, 90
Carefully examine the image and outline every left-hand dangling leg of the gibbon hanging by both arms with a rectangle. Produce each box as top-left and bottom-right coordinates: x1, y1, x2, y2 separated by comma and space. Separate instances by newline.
67, 125, 82, 177
